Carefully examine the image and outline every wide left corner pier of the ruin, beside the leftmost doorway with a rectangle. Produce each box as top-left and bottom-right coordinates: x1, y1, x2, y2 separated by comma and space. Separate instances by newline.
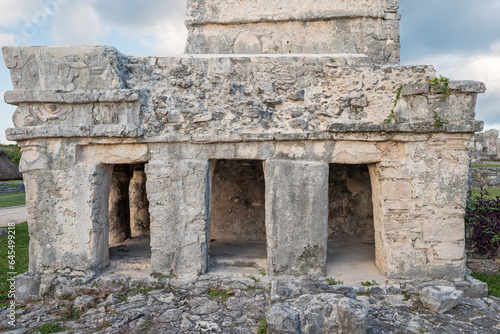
21, 143, 112, 276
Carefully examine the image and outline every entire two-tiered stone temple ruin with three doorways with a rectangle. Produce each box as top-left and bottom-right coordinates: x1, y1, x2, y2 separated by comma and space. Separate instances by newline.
3, 0, 485, 292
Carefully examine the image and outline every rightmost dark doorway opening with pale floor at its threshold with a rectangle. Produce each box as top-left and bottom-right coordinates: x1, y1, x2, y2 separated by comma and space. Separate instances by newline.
326, 164, 385, 283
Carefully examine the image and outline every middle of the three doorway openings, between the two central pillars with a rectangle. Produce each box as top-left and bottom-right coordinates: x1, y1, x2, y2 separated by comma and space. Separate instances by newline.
209, 160, 267, 273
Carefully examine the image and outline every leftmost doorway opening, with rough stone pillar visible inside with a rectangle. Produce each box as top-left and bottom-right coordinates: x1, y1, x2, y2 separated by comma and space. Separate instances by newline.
108, 163, 151, 274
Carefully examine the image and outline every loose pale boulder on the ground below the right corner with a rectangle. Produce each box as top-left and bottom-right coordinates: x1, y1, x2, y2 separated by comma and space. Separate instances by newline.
420, 285, 464, 314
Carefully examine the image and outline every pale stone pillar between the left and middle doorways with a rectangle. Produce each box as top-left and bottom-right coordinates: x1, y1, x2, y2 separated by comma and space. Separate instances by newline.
146, 160, 211, 275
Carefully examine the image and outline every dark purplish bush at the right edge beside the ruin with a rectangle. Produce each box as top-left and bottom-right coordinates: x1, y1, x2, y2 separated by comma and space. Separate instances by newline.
465, 189, 500, 258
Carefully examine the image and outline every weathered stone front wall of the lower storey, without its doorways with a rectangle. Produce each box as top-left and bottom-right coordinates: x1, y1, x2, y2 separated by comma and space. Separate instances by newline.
3, 47, 484, 280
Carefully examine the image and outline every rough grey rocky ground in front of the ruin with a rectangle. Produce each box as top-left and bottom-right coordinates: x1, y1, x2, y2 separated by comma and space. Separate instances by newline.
0, 276, 500, 333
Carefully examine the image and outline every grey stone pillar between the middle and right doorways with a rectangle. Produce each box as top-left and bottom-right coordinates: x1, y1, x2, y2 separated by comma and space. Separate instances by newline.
265, 160, 328, 275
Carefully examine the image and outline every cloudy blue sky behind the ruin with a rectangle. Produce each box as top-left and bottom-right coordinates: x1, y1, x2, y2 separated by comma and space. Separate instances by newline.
0, 0, 500, 143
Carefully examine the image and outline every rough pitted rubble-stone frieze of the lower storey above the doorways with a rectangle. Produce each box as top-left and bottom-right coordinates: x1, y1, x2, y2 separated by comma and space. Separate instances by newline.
4, 47, 477, 141
